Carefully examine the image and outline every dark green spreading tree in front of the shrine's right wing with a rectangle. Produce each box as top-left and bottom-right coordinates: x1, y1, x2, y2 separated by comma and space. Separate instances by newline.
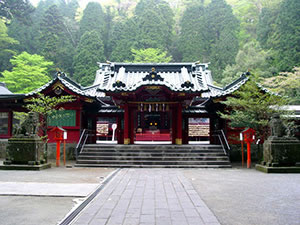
219, 77, 286, 138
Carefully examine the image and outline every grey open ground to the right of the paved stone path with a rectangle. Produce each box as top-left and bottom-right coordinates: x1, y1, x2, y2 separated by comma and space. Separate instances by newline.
184, 165, 300, 225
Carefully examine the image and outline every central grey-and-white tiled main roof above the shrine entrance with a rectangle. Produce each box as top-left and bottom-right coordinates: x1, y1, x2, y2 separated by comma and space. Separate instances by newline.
94, 63, 210, 92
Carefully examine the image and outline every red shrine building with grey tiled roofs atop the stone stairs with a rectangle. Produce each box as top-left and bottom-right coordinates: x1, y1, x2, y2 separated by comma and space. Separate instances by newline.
0, 63, 248, 145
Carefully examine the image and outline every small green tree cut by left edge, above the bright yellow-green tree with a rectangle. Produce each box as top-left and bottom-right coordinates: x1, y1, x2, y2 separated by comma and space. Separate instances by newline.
0, 19, 19, 71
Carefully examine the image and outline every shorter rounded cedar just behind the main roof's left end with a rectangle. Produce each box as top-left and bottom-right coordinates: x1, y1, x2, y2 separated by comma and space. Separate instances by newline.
74, 31, 105, 86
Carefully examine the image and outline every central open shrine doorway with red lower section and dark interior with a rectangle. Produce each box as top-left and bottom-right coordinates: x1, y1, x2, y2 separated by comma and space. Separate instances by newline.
134, 112, 172, 144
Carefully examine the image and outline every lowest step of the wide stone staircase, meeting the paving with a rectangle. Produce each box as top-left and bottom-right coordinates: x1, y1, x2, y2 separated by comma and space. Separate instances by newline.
75, 164, 232, 169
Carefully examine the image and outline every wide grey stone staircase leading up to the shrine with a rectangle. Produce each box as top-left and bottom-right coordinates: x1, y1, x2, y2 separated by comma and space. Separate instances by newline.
75, 144, 231, 168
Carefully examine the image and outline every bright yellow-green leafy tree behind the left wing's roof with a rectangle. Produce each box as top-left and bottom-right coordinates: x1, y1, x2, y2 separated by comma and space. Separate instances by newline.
0, 52, 53, 93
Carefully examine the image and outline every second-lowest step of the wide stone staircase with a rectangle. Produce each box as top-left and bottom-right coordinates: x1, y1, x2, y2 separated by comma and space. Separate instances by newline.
76, 159, 230, 165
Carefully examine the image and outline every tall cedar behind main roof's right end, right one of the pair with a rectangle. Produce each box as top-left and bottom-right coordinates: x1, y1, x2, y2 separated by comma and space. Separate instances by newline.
206, 0, 239, 81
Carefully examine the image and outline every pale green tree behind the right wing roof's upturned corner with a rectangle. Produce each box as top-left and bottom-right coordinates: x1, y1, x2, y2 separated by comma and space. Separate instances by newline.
221, 41, 276, 85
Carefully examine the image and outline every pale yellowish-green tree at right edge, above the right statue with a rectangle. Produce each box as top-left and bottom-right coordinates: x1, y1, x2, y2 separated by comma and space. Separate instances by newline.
263, 67, 300, 104
